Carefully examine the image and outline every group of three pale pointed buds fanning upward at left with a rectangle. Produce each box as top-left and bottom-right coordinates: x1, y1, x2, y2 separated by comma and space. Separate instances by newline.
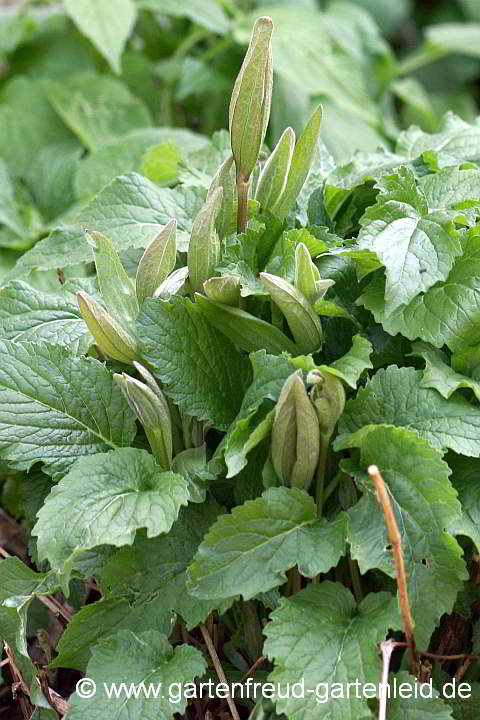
77, 220, 177, 365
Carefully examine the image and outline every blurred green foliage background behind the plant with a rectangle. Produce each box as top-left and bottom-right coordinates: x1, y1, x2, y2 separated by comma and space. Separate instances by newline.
0, 0, 480, 277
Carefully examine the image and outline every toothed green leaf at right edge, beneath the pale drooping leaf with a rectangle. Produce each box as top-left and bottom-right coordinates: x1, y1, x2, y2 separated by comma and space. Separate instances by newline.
358, 227, 480, 351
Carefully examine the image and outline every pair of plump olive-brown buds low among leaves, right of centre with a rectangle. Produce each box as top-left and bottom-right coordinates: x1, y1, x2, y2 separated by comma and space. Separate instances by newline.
271, 368, 345, 490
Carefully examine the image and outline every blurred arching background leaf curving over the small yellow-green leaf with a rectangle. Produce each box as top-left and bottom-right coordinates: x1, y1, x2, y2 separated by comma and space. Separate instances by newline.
74, 127, 207, 200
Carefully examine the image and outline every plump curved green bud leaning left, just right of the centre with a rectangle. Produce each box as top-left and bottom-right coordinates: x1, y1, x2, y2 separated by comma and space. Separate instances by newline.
260, 273, 322, 353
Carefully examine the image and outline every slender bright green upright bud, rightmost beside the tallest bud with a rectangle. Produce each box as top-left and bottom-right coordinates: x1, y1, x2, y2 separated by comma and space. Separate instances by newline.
275, 105, 322, 219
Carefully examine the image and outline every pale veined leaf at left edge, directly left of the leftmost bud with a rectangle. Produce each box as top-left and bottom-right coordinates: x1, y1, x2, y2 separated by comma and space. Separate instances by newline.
0, 281, 93, 355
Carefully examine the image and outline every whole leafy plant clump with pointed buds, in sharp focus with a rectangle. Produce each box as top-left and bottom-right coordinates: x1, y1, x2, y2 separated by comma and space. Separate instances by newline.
0, 1, 480, 720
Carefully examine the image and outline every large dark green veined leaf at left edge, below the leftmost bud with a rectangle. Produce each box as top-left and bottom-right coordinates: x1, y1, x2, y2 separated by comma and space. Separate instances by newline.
0, 340, 136, 476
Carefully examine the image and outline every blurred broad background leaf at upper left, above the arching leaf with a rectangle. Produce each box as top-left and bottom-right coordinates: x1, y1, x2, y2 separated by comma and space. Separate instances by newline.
43, 73, 152, 150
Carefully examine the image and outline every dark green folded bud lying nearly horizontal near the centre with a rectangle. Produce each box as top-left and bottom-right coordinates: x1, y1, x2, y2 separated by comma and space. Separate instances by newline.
195, 294, 298, 355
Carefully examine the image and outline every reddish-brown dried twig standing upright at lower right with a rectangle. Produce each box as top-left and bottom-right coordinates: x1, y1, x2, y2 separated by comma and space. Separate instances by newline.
368, 465, 417, 669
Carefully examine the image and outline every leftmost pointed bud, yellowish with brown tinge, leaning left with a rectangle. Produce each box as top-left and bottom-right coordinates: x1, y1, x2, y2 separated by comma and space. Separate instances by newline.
77, 292, 140, 364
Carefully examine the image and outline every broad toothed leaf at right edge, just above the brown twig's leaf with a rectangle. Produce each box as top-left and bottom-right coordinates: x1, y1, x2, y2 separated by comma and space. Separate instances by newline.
336, 365, 480, 456
